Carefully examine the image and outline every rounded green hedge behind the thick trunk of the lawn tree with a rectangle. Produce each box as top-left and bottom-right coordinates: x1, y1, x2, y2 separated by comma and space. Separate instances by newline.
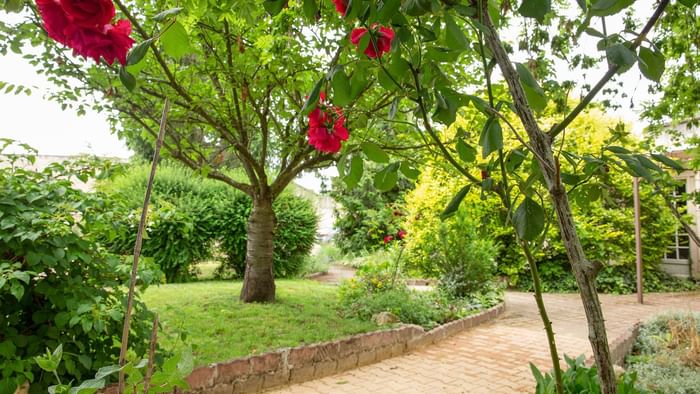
99, 163, 317, 282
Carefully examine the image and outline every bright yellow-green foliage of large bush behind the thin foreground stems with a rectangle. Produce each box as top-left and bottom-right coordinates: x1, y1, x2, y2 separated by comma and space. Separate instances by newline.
405, 110, 675, 291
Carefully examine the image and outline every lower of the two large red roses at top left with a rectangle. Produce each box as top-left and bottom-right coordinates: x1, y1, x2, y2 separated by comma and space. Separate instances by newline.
68, 19, 134, 65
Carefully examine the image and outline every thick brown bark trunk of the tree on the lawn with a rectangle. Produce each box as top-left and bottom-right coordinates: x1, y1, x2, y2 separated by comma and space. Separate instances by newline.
241, 195, 275, 302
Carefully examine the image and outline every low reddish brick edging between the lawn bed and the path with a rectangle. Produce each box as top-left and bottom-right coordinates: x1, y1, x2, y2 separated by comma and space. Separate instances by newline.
175, 302, 505, 394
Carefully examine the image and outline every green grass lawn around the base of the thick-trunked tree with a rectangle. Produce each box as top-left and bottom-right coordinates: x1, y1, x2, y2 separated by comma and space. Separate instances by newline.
143, 280, 377, 365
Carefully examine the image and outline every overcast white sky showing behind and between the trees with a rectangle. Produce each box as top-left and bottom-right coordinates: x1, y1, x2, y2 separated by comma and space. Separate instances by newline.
0, 0, 664, 191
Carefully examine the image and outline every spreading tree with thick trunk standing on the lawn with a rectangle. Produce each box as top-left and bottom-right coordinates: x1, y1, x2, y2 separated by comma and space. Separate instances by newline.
0, 0, 391, 302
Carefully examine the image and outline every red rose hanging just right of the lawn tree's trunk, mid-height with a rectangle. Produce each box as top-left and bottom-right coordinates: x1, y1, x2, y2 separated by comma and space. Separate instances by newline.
308, 93, 350, 153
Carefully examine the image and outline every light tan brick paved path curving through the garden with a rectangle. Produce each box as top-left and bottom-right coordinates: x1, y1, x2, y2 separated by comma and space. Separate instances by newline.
276, 292, 700, 394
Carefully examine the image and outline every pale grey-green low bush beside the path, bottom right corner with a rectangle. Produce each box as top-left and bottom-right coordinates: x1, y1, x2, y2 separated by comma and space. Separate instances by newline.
627, 313, 700, 394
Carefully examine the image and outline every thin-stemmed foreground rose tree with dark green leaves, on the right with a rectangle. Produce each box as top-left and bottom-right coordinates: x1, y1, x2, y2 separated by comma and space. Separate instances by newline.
314, 0, 692, 393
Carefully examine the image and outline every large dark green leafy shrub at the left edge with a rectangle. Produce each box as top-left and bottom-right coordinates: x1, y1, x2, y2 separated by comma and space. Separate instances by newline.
0, 149, 152, 393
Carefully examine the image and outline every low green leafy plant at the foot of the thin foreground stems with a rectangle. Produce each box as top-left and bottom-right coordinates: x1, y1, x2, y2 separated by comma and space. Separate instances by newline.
530, 355, 648, 394
